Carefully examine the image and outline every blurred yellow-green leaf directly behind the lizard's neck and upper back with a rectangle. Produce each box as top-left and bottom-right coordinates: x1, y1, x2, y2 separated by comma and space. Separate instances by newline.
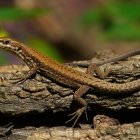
27, 37, 63, 62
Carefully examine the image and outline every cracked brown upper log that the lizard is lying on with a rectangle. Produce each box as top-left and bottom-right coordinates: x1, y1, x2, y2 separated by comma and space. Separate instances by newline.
0, 55, 140, 114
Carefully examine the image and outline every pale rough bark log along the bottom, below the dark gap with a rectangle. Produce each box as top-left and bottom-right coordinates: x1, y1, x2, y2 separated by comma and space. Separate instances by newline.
3, 123, 140, 140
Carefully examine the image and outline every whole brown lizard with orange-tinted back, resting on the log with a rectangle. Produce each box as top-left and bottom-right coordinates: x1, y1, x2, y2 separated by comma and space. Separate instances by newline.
0, 38, 140, 124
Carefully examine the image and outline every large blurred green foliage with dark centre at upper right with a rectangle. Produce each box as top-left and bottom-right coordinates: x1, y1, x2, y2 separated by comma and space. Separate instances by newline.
78, 1, 140, 40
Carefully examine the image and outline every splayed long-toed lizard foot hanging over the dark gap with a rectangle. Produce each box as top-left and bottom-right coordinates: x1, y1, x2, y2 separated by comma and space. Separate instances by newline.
66, 107, 88, 127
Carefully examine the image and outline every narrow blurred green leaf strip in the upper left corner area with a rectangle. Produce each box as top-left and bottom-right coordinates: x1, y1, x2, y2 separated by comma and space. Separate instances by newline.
0, 7, 48, 20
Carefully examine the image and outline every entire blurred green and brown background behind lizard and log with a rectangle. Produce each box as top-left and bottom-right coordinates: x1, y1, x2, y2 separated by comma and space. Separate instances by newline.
0, 0, 140, 65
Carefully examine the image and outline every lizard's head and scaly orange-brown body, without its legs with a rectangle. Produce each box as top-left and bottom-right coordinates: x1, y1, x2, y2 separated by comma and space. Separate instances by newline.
0, 38, 140, 94
